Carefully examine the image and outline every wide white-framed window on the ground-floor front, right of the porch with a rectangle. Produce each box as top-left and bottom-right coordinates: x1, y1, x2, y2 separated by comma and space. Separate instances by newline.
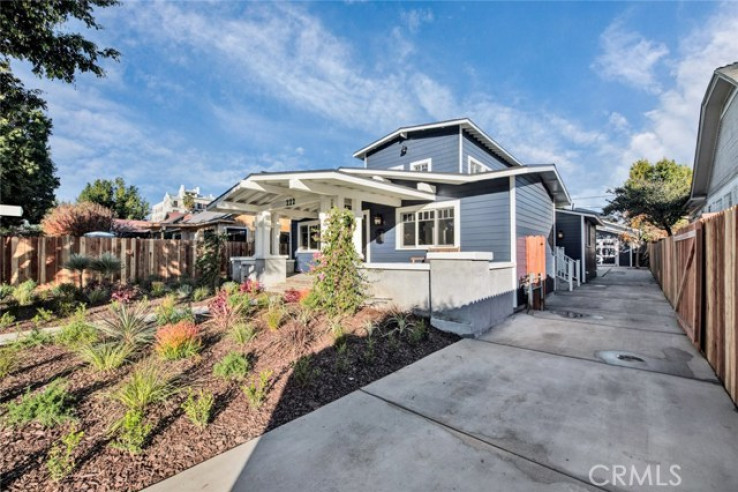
397, 202, 459, 249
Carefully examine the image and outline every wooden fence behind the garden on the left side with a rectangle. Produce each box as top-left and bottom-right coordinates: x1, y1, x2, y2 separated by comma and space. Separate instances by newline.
0, 236, 250, 285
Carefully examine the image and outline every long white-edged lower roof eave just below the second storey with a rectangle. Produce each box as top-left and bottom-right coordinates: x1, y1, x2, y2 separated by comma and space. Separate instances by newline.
340, 164, 571, 207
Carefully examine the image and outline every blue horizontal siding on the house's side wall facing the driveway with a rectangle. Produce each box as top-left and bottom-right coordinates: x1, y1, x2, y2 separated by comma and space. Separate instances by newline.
515, 177, 556, 277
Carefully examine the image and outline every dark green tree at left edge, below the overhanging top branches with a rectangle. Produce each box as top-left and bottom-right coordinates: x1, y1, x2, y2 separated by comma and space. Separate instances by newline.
0, 62, 59, 225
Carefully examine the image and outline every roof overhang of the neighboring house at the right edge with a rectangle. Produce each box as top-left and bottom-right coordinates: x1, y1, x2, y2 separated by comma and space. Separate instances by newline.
690, 62, 738, 207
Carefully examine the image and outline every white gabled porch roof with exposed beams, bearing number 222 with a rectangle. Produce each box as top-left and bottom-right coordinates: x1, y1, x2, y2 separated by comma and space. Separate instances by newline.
208, 170, 436, 219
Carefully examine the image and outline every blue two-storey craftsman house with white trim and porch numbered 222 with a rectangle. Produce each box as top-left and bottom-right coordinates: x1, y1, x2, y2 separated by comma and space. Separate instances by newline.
209, 118, 570, 332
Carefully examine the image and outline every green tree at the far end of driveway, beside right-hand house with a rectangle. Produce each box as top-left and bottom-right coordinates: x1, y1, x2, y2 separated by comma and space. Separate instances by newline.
604, 159, 692, 236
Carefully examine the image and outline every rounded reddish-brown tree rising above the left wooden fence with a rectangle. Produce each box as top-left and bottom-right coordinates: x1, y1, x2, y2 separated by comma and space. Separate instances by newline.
41, 202, 113, 237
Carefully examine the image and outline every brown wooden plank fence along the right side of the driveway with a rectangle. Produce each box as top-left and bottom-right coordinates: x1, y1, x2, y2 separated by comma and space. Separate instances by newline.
648, 207, 738, 403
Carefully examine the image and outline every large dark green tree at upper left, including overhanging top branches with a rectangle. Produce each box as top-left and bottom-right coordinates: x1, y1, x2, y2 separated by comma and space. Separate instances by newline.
0, 0, 119, 224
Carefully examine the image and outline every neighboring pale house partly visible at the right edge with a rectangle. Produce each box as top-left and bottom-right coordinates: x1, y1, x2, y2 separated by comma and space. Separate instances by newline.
690, 63, 738, 215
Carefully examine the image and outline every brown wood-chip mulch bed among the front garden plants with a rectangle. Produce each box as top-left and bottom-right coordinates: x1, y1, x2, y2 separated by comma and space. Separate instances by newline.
0, 308, 458, 491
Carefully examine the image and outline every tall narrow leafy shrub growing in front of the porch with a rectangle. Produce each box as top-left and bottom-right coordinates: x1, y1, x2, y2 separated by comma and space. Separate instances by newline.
306, 208, 366, 316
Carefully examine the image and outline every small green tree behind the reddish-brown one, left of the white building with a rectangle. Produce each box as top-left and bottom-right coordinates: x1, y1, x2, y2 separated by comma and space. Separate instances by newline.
77, 178, 149, 220
